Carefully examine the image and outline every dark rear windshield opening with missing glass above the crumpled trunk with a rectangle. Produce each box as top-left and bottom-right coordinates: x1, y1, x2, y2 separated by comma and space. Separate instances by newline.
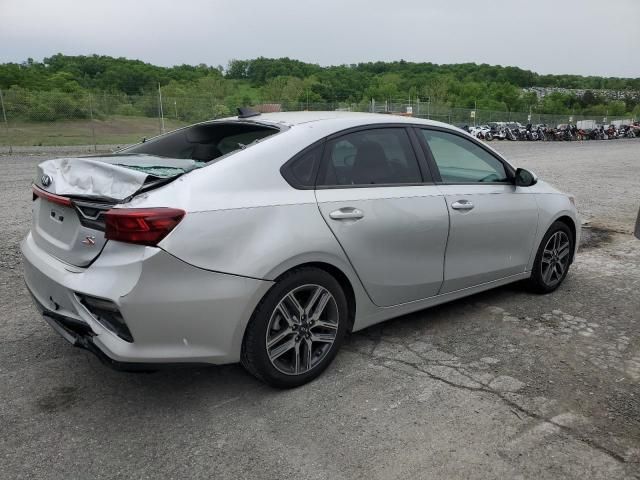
118, 122, 280, 162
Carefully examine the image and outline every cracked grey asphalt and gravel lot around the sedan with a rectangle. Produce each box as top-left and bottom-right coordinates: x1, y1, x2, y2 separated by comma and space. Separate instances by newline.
0, 139, 640, 479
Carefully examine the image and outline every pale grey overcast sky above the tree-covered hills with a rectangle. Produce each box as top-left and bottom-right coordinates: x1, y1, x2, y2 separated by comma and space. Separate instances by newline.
0, 0, 640, 78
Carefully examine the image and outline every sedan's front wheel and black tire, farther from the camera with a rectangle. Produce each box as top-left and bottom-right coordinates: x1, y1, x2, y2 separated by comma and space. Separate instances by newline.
529, 222, 575, 293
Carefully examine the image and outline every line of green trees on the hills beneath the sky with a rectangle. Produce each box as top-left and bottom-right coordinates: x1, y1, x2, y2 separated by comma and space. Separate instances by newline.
0, 54, 640, 119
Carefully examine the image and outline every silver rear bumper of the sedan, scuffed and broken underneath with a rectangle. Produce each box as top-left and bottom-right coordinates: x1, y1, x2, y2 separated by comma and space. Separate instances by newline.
21, 234, 272, 364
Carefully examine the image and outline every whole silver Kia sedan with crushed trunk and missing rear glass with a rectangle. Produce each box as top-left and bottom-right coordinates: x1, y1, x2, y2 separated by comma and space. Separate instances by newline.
22, 110, 580, 387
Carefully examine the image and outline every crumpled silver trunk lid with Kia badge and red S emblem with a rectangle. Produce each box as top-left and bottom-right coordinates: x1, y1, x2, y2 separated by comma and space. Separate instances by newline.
31, 155, 198, 267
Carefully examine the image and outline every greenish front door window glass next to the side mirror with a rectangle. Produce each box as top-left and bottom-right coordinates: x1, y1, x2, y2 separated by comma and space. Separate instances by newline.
421, 130, 509, 183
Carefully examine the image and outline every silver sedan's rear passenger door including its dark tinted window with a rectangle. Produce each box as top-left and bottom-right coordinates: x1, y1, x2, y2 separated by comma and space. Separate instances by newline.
316, 127, 449, 306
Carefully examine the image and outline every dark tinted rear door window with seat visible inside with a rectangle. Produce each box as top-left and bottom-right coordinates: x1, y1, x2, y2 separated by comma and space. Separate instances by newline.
318, 128, 422, 186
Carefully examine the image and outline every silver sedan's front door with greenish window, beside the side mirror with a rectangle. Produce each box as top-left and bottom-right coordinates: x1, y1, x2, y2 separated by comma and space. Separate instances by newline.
418, 129, 538, 293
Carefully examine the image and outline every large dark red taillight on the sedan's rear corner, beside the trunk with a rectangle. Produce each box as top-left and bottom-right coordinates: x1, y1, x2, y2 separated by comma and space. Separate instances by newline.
104, 208, 185, 246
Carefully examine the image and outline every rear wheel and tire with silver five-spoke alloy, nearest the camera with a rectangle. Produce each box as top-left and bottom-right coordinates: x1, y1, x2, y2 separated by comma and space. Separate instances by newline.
240, 267, 348, 388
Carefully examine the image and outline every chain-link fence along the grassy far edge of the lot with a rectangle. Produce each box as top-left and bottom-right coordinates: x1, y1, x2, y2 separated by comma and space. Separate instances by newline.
0, 89, 626, 151
